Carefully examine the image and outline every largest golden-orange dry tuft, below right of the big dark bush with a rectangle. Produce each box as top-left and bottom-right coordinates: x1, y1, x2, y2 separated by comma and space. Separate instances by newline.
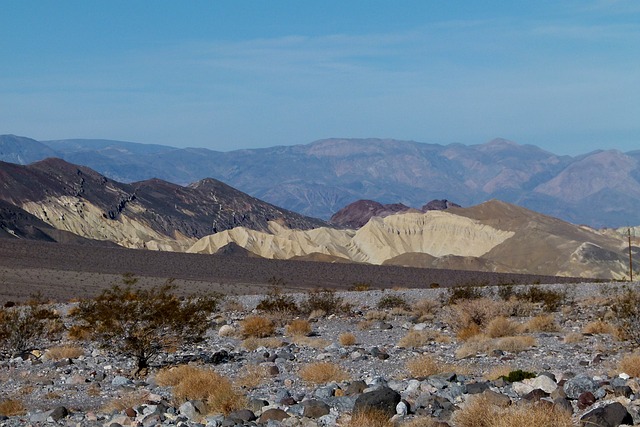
156, 365, 246, 415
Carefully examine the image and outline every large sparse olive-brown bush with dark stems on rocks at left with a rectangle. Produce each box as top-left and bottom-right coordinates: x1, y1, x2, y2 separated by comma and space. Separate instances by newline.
73, 277, 221, 374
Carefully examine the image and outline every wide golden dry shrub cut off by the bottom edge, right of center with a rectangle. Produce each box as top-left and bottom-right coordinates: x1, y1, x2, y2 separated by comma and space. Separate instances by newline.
453, 394, 573, 427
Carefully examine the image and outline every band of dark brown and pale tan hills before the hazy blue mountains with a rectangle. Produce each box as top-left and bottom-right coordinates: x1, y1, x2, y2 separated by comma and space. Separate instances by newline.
0, 158, 640, 279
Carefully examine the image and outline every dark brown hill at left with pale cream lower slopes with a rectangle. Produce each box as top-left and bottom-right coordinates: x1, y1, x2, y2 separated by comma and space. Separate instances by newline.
0, 158, 326, 247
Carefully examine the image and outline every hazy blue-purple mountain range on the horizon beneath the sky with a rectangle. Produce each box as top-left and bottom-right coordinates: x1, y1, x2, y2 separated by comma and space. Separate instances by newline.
0, 135, 640, 227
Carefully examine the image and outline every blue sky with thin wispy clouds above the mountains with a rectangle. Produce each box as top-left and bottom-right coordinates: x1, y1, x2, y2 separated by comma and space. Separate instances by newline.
0, 0, 640, 154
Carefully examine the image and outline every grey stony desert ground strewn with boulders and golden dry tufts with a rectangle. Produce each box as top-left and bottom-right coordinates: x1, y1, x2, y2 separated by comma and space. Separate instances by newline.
0, 283, 640, 427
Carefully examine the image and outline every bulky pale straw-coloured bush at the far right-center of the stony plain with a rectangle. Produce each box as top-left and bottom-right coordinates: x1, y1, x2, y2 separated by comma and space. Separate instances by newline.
445, 298, 508, 332
